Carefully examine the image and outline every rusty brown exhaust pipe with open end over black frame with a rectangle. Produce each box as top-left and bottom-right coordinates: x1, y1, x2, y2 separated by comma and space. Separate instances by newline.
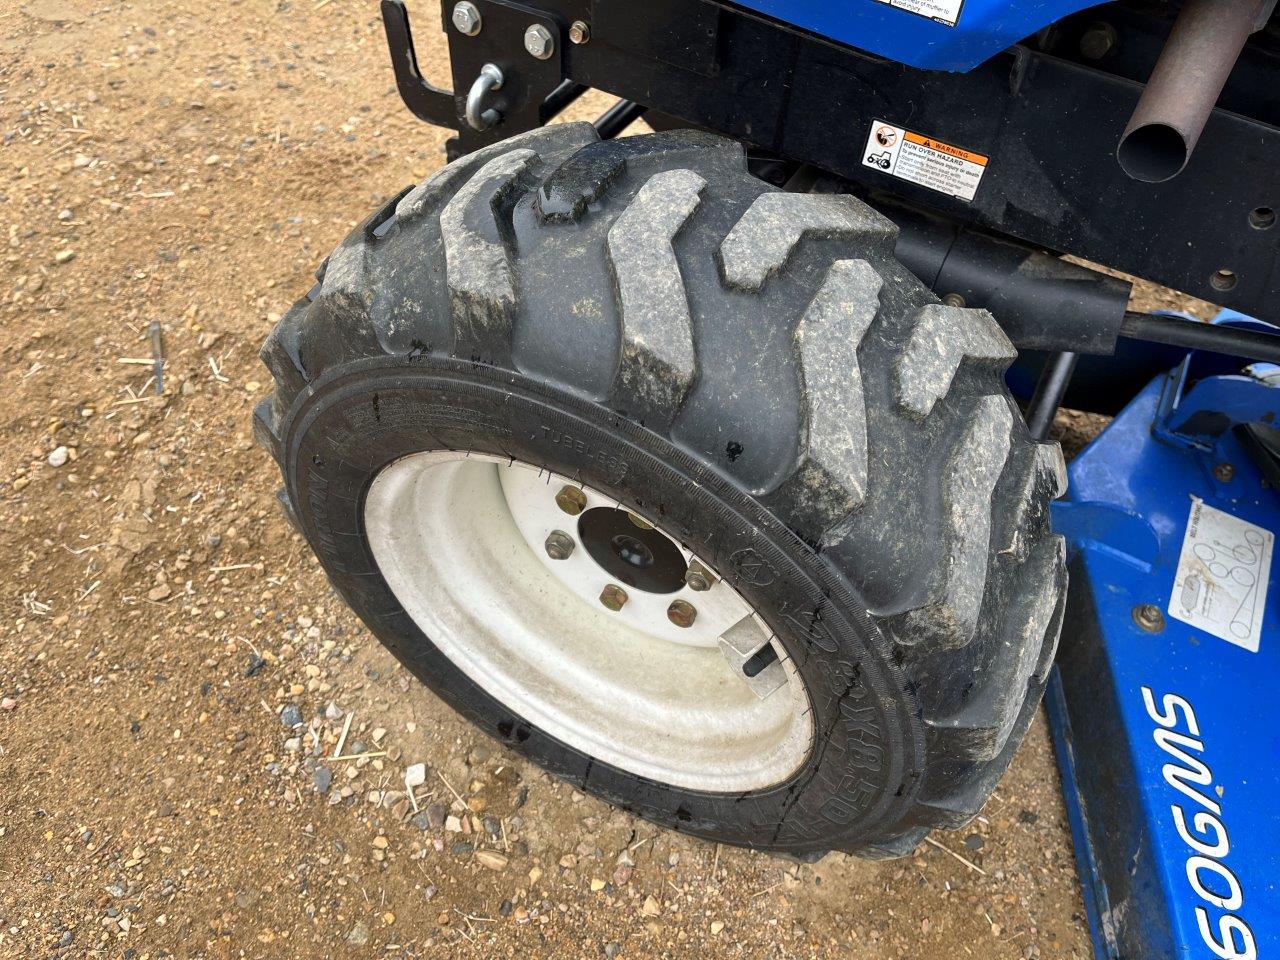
1116, 0, 1276, 183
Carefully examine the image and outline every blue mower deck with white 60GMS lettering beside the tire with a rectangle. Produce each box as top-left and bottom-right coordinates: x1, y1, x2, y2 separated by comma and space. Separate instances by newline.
1048, 371, 1280, 960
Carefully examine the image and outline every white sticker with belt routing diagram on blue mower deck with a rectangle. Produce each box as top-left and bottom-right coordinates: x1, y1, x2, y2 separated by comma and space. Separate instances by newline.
1169, 499, 1276, 653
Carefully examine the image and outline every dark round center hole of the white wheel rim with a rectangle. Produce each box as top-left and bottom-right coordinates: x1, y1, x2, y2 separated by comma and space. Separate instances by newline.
577, 507, 689, 594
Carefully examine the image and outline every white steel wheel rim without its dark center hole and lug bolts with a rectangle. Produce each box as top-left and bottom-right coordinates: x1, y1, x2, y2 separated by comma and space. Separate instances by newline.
365, 451, 813, 792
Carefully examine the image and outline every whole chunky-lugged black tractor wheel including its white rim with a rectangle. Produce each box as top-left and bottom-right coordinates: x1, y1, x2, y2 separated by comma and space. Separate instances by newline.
255, 124, 1066, 859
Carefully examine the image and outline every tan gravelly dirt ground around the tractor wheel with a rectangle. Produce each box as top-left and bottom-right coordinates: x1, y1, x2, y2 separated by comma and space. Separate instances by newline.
0, 0, 1213, 960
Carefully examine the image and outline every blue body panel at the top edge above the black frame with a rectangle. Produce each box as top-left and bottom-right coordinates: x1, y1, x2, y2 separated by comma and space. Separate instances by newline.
739, 0, 1098, 72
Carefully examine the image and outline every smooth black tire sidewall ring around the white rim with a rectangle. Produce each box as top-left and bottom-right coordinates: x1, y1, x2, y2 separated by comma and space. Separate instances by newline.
284, 357, 924, 855
